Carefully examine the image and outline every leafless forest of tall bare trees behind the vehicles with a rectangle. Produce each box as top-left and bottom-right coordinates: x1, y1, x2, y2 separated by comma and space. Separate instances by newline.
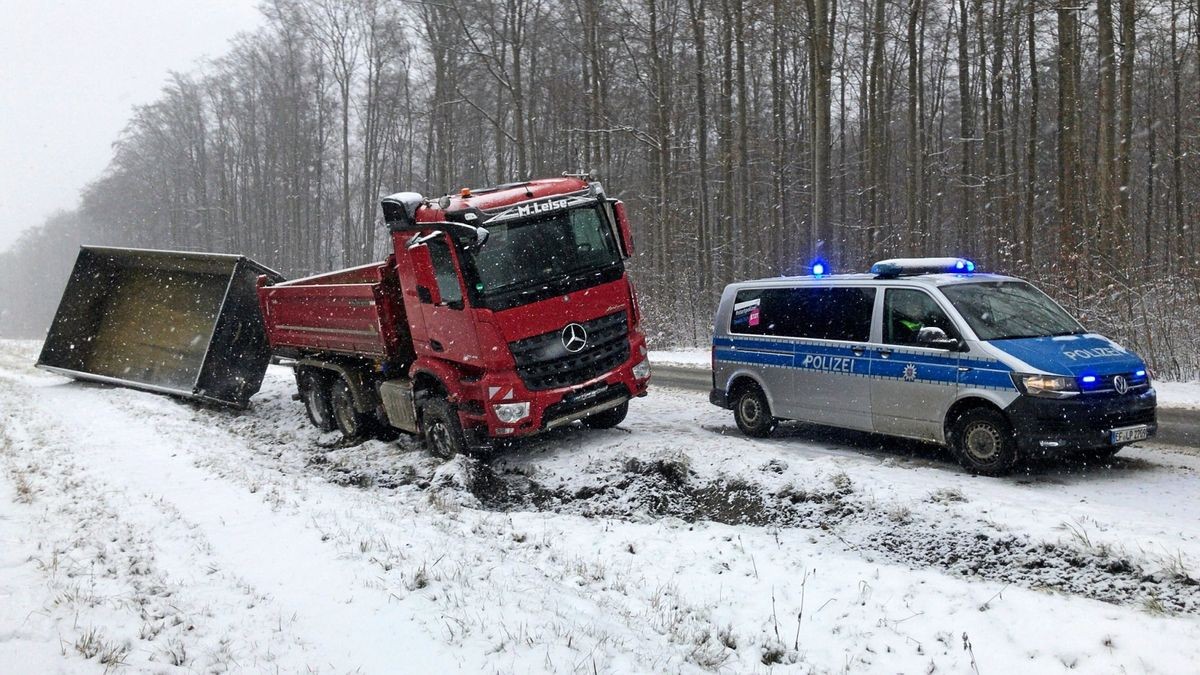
0, 0, 1200, 377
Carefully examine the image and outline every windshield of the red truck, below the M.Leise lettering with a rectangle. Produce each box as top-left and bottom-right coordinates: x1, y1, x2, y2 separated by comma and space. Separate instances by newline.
473, 205, 620, 297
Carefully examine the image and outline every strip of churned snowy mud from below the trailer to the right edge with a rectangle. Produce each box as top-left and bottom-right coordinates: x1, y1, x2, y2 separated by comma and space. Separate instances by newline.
198, 379, 1200, 615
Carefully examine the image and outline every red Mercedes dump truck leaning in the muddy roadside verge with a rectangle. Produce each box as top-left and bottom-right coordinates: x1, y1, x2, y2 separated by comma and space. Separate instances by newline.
258, 175, 650, 456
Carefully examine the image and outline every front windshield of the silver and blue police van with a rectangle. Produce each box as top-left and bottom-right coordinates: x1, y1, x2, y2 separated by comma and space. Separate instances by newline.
941, 281, 1084, 340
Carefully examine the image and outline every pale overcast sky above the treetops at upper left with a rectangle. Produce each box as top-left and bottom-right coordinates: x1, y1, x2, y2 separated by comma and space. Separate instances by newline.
0, 0, 262, 250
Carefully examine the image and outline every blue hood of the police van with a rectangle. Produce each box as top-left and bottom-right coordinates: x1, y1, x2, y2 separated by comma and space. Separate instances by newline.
988, 333, 1146, 376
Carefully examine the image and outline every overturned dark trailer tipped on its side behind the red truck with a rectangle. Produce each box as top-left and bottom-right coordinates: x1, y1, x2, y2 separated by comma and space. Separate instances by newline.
37, 246, 283, 407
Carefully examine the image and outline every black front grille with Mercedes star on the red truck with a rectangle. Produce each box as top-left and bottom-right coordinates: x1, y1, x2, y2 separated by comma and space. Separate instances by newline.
509, 311, 629, 392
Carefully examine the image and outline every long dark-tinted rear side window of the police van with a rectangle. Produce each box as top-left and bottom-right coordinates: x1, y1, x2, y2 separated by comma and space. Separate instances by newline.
730, 287, 875, 342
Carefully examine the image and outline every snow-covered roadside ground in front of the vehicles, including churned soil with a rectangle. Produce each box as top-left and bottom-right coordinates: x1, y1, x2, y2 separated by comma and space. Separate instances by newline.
7, 341, 1200, 674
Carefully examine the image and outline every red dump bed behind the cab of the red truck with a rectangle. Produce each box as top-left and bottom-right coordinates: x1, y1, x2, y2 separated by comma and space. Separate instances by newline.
258, 257, 413, 360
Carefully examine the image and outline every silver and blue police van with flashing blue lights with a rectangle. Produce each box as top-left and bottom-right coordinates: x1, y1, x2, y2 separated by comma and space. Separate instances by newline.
709, 258, 1157, 474
